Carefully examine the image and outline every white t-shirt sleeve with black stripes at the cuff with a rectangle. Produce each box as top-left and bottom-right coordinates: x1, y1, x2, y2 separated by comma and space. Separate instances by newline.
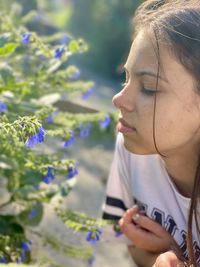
103, 134, 134, 220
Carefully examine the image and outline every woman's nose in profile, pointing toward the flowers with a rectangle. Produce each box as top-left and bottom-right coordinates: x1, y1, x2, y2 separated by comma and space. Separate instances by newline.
112, 88, 135, 112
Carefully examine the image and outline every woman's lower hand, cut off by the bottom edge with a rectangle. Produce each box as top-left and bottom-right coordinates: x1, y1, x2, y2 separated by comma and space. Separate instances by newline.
153, 251, 187, 267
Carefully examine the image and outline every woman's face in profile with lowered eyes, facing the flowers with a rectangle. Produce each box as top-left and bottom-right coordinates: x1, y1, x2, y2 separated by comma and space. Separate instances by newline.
113, 31, 200, 156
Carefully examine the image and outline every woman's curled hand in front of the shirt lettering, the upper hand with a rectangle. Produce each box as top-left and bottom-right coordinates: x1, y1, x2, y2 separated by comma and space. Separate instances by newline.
119, 206, 179, 254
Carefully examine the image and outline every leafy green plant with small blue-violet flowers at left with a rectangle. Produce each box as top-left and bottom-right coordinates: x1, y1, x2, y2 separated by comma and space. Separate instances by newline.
0, 1, 115, 266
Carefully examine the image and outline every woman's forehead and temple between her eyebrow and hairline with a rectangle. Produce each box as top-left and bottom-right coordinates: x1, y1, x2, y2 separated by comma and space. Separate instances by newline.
125, 31, 194, 89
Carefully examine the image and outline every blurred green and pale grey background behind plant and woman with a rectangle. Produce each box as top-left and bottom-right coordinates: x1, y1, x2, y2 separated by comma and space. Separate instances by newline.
0, 0, 141, 267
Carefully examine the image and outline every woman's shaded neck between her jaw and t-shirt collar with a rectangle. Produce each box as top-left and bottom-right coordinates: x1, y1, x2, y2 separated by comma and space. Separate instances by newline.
162, 152, 198, 197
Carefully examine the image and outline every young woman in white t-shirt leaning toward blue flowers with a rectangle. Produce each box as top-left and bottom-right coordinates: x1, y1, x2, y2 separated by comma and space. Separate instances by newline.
103, 0, 200, 267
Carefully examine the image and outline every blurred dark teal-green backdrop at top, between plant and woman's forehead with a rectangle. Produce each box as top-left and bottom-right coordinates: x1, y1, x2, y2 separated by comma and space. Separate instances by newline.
0, 0, 141, 81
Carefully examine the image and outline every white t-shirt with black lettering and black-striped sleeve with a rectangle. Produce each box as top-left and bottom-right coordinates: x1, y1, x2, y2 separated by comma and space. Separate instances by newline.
103, 134, 200, 262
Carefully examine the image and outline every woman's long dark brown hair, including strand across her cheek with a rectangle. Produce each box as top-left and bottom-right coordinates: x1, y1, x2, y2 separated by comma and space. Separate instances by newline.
133, 0, 200, 266
